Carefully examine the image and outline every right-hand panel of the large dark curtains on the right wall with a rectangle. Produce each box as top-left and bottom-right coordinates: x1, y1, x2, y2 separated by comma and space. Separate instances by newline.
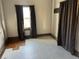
65, 0, 78, 54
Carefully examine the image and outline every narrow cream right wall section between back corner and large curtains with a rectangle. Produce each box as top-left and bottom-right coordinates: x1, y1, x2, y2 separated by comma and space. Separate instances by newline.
51, 0, 65, 38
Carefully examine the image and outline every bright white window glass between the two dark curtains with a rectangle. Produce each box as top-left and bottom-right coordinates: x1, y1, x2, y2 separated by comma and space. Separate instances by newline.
23, 7, 31, 29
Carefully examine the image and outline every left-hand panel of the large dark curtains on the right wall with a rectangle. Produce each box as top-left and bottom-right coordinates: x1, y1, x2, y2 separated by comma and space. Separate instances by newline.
58, 2, 68, 47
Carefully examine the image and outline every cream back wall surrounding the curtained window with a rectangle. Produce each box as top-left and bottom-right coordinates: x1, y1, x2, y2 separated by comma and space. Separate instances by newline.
3, 0, 52, 37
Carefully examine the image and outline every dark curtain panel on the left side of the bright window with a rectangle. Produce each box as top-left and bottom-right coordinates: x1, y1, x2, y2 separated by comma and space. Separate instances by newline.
15, 5, 24, 40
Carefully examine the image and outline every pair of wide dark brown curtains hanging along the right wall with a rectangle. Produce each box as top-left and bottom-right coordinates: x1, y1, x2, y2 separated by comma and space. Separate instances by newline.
58, 0, 77, 54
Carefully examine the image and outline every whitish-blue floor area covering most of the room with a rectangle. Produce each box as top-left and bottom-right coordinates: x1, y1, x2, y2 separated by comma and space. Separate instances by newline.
2, 39, 78, 59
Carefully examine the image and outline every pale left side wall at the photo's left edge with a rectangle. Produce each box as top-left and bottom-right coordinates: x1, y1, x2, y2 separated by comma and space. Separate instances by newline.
0, 0, 7, 54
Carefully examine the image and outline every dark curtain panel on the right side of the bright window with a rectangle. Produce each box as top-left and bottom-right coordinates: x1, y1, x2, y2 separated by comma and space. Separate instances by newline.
30, 6, 37, 38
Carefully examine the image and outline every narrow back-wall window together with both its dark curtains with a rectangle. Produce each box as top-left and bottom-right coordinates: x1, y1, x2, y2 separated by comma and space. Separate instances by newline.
15, 5, 37, 40
